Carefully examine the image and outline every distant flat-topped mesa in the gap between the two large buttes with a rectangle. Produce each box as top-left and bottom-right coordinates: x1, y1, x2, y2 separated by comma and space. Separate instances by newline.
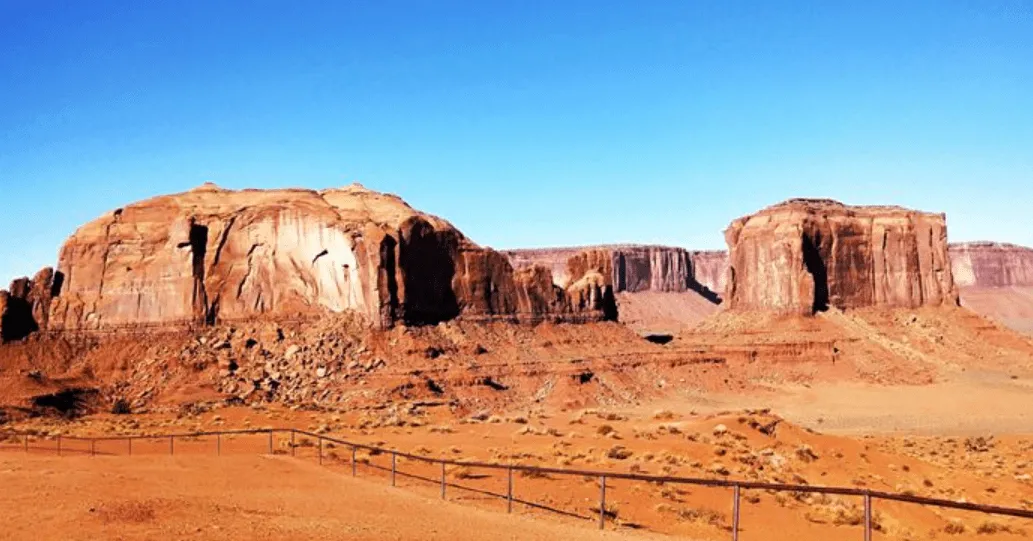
505, 245, 724, 300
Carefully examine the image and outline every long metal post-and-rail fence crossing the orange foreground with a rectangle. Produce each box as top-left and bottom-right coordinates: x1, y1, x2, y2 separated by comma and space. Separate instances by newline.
0, 428, 1033, 541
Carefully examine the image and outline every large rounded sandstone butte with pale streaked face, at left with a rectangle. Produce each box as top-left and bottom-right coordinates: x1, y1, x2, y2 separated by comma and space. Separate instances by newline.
0, 184, 617, 340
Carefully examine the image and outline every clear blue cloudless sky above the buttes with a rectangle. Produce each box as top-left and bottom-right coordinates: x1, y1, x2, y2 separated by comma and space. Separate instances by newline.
0, 0, 1033, 287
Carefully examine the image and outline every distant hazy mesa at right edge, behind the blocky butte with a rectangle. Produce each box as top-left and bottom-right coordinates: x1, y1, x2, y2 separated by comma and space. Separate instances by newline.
948, 242, 1033, 287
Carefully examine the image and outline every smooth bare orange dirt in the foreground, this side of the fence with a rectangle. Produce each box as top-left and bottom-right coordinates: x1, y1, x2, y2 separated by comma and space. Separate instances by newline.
0, 452, 677, 541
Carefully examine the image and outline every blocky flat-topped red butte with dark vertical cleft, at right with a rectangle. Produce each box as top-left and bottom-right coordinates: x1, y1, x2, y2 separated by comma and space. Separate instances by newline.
725, 199, 958, 315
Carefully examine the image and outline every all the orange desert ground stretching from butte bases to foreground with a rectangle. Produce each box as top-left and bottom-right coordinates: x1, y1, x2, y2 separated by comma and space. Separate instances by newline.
6, 303, 1033, 541
